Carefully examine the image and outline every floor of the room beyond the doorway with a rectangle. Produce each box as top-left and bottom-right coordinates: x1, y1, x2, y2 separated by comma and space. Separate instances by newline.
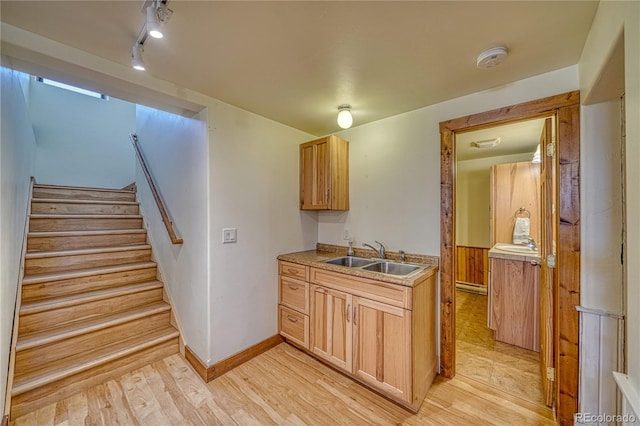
456, 290, 544, 405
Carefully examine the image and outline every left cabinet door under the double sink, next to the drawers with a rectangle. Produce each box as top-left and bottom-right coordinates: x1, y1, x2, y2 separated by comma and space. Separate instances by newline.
310, 285, 353, 372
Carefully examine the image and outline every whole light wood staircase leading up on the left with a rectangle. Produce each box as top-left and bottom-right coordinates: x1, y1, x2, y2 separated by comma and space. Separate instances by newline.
11, 185, 179, 418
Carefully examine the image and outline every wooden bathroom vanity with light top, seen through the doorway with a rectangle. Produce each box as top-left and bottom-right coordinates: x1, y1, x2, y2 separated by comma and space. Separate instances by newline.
488, 244, 540, 352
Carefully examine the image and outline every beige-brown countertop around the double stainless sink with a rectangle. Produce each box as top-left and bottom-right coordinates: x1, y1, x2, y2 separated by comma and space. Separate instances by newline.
278, 248, 438, 287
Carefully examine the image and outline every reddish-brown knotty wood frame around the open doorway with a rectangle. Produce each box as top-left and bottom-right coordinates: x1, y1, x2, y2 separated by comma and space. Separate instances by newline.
440, 91, 580, 424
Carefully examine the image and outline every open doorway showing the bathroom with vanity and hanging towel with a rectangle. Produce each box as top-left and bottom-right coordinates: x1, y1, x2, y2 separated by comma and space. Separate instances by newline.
454, 117, 554, 405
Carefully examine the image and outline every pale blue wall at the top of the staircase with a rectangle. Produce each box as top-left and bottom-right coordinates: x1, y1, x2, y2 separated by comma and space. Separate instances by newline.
29, 81, 136, 188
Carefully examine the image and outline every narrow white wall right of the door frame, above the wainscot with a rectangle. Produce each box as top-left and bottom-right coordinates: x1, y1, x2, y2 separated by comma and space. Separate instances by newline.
580, 100, 633, 314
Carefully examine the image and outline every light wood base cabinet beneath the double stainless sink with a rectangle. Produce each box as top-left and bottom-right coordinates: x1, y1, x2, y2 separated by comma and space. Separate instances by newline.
280, 261, 437, 411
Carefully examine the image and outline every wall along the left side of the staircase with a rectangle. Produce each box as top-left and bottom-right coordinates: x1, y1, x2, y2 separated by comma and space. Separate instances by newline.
0, 63, 36, 420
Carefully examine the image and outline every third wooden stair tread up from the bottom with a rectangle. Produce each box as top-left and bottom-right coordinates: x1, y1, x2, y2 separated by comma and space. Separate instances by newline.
20, 281, 163, 316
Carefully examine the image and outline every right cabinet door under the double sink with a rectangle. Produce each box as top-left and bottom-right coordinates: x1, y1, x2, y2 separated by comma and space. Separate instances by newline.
353, 297, 412, 402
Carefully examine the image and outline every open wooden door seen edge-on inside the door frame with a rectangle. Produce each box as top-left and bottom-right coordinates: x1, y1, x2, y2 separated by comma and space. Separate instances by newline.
540, 118, 558, 407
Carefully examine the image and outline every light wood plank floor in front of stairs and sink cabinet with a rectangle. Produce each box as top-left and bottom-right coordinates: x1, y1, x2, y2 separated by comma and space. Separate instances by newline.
13, 343, 554, 426
